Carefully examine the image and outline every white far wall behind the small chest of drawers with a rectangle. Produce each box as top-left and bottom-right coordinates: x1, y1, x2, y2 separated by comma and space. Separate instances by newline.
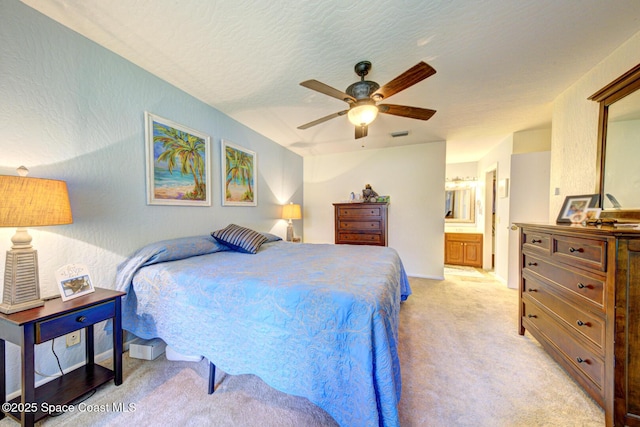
303, 142, 446, 277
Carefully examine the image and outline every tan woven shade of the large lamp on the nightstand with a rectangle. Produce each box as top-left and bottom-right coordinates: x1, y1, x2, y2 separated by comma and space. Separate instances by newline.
0, 175, 73, 227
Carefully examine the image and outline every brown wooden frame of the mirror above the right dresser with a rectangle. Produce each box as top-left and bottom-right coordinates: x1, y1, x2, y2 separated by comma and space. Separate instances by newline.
588, 64, 640, 219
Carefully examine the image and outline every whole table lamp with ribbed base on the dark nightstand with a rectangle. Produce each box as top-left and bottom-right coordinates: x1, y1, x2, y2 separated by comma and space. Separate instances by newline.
0, 166, 73, 314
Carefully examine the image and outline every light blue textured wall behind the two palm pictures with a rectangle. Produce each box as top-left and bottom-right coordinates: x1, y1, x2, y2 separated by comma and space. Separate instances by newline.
0, 0, 303, 391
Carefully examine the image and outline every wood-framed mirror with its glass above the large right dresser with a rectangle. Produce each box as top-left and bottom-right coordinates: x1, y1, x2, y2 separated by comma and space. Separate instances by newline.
589, 65, 640, 218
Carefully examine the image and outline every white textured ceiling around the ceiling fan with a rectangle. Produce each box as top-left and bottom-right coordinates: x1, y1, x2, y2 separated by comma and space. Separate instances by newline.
23, 0, 640, 163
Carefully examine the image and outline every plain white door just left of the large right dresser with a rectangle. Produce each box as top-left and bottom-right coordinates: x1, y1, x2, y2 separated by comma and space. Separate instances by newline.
507, 151, 551, 288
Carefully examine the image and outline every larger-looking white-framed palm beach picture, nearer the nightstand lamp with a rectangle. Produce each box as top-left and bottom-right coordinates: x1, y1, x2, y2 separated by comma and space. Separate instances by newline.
144, 112, 211, 206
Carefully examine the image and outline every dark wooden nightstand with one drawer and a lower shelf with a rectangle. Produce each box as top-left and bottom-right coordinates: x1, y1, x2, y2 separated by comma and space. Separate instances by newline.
0, 288, 124, 426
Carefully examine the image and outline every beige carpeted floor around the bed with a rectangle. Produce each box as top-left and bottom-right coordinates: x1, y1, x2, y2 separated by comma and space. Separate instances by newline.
0, 272, 604, 427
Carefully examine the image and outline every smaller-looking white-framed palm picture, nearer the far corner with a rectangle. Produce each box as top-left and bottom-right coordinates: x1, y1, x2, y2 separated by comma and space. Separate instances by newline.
221, 140, 258, 206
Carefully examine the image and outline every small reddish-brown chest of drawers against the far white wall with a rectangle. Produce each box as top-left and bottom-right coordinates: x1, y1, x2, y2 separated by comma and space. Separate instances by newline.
333, 203, 389, 246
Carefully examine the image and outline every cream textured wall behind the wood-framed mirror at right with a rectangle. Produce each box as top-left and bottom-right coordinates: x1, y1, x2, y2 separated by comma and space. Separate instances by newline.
549, 32, 640, 222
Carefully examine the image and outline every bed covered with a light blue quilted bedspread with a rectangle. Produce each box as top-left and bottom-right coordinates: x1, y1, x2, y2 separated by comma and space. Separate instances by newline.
116, 229, 411, 426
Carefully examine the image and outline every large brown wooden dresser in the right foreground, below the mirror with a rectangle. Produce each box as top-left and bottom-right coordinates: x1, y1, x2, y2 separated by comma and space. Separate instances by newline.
517, 224, 640, 426
